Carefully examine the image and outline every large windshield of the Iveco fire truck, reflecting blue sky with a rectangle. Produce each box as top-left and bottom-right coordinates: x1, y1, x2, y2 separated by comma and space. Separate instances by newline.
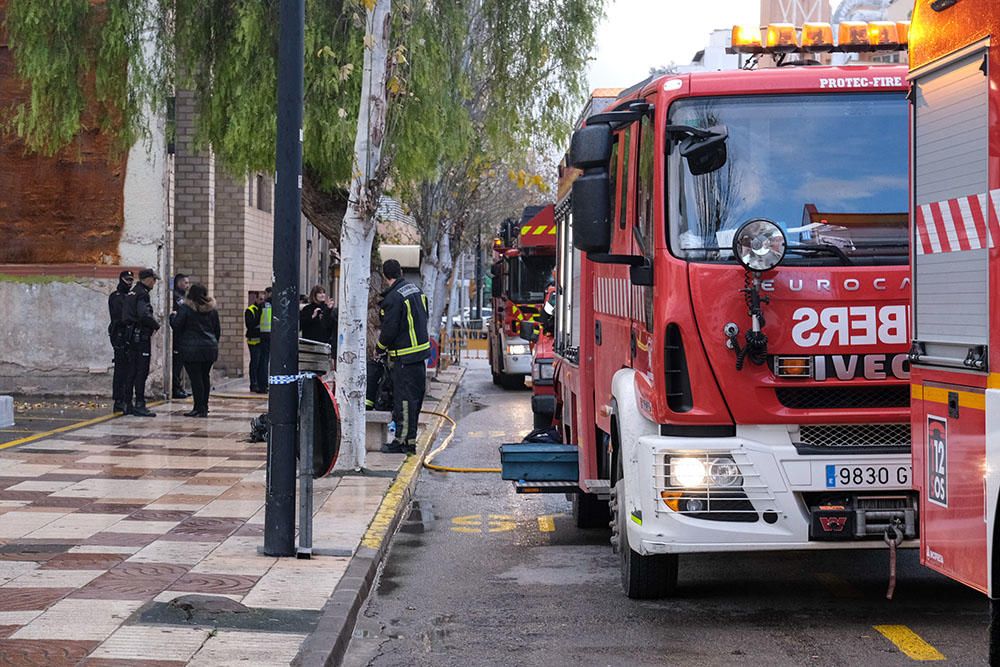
668, 93, 909, 265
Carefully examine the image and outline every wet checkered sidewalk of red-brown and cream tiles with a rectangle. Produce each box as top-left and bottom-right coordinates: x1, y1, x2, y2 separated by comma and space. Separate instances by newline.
0, 378, 450, 667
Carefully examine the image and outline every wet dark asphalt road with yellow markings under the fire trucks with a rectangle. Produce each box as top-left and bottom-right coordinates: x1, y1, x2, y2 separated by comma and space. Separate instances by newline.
344, 361, 987, 667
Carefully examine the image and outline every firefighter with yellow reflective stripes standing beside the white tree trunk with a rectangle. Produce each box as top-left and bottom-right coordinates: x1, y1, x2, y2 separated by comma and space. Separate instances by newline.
378, 259, 431, 454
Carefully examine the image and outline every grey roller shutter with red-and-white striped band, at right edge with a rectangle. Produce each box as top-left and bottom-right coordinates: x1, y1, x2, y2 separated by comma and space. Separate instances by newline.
910, 49, 992, 367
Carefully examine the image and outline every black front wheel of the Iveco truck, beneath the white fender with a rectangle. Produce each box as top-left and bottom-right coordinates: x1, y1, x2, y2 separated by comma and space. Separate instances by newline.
611, 454, 677, 600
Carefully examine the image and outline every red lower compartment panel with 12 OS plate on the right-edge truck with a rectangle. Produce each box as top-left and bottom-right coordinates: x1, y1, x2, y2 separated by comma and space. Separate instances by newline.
913, 382, 989, 593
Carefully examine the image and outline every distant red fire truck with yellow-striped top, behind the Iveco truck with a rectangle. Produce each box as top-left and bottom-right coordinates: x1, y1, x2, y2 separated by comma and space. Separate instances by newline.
489, 204, 556, 389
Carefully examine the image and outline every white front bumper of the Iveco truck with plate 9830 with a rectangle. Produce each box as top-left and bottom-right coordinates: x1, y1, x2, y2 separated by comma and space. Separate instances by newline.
626, 426, 917, 554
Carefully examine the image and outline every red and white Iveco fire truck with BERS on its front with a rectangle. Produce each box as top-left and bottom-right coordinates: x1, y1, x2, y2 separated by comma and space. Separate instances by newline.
502, 23, 917, 598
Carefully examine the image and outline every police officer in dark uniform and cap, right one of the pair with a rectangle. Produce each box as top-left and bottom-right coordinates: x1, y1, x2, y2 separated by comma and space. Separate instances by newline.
123, 269, 160, 417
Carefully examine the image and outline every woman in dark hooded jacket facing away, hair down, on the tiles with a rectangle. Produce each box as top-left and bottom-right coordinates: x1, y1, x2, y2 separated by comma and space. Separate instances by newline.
170, 283, 222, 417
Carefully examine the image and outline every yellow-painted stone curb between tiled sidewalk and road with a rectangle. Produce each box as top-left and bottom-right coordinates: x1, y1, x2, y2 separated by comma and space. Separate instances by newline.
291, 367, 465, 667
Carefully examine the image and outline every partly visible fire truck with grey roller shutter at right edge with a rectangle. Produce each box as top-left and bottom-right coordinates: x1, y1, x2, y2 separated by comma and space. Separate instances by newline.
910, 0, 1000, 648
